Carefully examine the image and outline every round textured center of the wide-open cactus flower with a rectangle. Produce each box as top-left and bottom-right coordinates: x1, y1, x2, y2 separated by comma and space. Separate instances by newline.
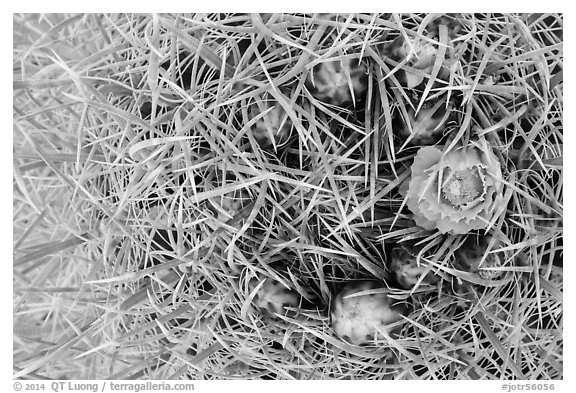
442, 168, 484, 207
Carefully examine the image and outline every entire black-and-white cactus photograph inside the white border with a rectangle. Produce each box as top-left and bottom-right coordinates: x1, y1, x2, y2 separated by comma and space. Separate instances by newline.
12, 12, 564, 380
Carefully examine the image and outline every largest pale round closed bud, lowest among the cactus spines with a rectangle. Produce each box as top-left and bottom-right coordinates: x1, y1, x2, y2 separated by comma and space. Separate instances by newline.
331, 281, 406, 345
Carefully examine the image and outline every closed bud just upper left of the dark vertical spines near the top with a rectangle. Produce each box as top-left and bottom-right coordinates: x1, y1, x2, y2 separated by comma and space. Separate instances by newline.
306, 58, 368, 106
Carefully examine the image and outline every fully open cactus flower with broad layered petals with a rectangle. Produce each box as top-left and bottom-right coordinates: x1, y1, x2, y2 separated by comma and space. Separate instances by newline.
401, 140, 504, 234
